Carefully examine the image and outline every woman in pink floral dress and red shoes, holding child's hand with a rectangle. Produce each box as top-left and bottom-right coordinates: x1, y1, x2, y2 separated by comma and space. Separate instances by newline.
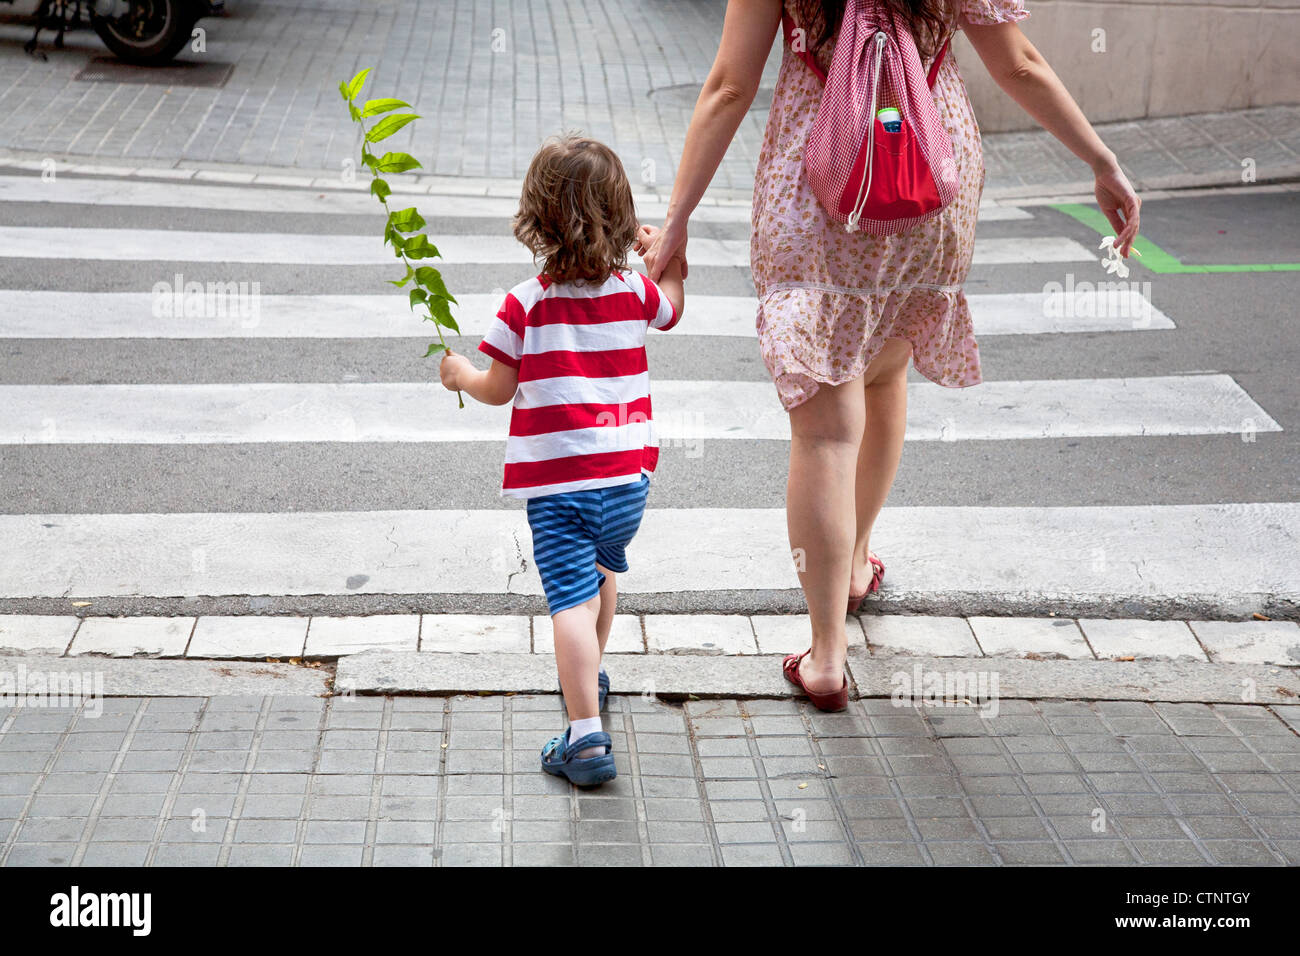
645, 0, 1140, 710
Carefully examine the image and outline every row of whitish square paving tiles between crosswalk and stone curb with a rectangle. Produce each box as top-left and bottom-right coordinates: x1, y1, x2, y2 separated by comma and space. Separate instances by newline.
0, 614, 1300, 667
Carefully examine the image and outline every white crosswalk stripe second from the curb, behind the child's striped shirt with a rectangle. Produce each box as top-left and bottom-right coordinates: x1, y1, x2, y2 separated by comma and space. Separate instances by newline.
0, 375, 1281, 445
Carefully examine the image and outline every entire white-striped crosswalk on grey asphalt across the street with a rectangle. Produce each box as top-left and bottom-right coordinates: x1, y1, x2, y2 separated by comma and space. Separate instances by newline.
0, 174, 1300, 613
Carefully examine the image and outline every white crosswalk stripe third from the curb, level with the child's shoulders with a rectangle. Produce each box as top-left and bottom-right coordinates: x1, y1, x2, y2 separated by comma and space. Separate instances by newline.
0, 287, 1174, 338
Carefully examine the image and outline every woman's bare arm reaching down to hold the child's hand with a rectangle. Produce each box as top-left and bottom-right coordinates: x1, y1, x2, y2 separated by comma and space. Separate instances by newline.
645, 0, 781, 281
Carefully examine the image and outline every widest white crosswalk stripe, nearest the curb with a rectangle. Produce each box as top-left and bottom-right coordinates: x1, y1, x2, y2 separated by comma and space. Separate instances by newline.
0, 503, 1300, 604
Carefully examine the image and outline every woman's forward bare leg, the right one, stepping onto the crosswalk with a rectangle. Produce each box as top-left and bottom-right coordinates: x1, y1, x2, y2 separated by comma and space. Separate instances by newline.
849, 338, 911, 594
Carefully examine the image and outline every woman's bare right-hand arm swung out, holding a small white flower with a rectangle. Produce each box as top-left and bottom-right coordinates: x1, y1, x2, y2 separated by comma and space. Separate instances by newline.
962, 20, 1141, 256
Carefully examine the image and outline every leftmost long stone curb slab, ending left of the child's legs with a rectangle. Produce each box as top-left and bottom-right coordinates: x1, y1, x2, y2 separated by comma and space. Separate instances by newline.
0, 654, 330, 704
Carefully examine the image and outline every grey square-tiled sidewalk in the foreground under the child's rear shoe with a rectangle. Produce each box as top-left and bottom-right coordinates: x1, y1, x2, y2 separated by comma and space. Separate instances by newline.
0, 696, 1300, 866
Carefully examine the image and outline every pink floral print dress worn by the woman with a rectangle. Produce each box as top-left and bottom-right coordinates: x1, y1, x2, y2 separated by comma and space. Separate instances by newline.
750, 0, 1030, 411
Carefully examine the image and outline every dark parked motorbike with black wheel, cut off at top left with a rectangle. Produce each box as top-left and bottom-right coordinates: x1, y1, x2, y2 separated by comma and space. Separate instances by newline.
0, 0, 225, 66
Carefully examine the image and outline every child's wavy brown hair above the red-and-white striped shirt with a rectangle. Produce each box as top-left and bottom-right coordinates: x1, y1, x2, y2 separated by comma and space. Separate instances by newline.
514, 133, 637, 282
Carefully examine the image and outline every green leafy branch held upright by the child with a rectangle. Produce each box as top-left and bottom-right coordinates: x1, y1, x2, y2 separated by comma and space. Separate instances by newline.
338, 68, 465, 408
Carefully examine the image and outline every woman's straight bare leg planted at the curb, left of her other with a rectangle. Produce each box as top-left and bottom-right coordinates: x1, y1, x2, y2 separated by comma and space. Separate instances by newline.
785, 378, 866, 693
